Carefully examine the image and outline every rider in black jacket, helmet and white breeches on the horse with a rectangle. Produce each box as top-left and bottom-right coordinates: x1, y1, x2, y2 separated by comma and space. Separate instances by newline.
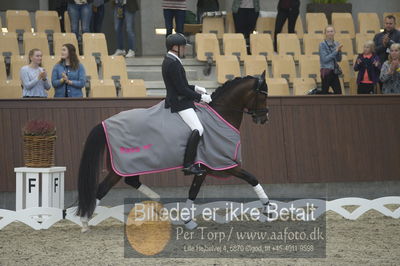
162, 33, 211, 175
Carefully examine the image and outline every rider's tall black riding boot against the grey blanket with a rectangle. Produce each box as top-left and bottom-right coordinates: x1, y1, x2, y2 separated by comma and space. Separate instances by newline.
183, 130, 206, 175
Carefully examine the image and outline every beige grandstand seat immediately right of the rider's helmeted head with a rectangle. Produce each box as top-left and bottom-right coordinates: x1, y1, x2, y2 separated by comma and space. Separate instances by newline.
195, 33, 220, 61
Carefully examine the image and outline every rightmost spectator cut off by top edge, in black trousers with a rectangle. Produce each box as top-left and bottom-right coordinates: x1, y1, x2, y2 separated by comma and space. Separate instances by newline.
274, 0, 300, 52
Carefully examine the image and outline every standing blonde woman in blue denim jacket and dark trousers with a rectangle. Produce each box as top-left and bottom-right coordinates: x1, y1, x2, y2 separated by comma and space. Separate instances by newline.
319, 26, 343, 94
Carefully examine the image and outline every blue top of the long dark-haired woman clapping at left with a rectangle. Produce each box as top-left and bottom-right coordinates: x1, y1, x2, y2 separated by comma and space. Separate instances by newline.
51, 64, 86, 97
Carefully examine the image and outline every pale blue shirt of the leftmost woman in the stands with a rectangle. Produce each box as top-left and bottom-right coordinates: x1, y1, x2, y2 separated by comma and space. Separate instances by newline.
20, 65, 50, 98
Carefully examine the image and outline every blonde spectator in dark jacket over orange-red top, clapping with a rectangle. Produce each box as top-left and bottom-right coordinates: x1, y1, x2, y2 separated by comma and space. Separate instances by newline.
354, 41, 381, 94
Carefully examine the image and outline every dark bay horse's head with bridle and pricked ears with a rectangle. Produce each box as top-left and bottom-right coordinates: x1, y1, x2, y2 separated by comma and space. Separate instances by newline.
245, 71, 268, 124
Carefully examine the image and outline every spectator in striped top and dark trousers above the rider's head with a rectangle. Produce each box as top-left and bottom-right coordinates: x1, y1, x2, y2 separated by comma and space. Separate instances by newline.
162, 0, 187, 37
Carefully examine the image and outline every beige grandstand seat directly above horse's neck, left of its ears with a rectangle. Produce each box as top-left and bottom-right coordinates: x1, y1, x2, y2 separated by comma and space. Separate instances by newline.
216, 55, 241, 84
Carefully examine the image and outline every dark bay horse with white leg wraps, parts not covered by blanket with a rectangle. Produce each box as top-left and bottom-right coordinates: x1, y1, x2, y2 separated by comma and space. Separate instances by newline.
77, 72, 269, 232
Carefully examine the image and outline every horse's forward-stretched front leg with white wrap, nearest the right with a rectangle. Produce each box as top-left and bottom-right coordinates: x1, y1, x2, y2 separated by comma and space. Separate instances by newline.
227, 167, 271, 220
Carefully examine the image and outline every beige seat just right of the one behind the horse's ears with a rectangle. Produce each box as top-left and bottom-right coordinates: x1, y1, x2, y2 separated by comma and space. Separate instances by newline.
271, 55, 297, 82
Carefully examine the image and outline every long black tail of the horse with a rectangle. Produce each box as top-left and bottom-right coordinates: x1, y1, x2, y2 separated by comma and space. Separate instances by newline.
76, 124, 106, 217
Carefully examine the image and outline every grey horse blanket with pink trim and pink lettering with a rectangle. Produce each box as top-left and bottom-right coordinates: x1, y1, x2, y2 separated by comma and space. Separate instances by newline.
103, 101, 241, 176
